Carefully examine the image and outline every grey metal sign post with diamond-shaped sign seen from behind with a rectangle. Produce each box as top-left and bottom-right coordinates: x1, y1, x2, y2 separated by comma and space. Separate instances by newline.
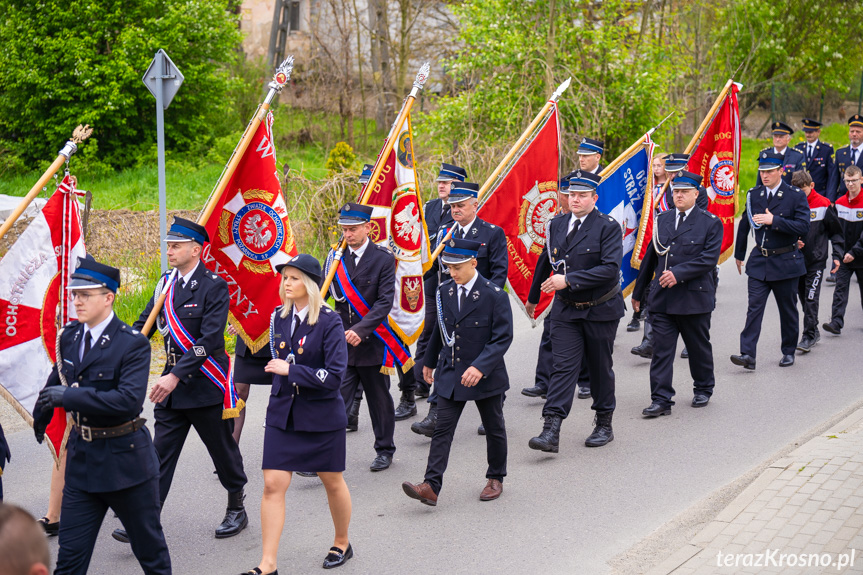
142, 50, 184, 273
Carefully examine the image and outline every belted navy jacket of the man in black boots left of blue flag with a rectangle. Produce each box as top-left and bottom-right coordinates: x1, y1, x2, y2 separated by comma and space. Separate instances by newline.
548, 209, 624, 321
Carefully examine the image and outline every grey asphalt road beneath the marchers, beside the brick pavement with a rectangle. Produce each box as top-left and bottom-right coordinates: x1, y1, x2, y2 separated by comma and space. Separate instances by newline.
3, 249, 863, 574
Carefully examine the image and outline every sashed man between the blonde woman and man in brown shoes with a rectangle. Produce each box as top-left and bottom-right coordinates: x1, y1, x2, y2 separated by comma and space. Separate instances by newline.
327, 202, 403, 471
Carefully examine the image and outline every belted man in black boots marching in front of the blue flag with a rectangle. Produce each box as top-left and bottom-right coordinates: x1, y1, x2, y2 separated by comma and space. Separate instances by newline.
528, 170, 624, 453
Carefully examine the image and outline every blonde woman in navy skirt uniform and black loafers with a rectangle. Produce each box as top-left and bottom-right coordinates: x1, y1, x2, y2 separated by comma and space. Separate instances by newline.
243, 254, 353, 575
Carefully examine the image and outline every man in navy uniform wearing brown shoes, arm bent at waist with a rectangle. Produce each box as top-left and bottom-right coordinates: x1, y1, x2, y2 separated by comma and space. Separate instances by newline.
402, 238, 512, 505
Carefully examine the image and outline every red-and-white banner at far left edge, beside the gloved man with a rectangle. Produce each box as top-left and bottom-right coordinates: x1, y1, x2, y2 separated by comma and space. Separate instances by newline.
0, 175, 86, 460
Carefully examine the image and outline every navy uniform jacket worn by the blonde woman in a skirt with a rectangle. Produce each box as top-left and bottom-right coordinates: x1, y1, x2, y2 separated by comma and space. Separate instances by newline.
267, 306, 348, 431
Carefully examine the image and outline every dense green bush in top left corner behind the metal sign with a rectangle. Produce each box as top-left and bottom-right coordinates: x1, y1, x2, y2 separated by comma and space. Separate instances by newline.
0, 0, 245, 169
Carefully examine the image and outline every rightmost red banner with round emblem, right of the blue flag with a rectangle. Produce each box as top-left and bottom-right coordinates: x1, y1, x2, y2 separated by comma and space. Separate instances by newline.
686, 84, 740, 263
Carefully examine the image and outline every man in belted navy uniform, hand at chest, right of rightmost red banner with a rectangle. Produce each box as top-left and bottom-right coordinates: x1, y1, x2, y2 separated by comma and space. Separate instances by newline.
731, 151, 809, 370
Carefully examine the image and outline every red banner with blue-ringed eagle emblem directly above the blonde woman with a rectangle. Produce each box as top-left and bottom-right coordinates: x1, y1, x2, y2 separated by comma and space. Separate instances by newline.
200, 113, 297, 352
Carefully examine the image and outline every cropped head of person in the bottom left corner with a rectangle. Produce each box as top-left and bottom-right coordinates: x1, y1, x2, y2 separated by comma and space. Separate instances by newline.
0, 502, 51, 575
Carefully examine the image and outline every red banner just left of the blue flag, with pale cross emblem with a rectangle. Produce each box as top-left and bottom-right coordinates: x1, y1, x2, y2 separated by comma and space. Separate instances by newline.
477, 104, 560, 321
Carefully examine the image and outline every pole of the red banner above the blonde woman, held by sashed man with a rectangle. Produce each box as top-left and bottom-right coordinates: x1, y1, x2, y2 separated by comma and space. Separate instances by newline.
141, 56, 294, 335
